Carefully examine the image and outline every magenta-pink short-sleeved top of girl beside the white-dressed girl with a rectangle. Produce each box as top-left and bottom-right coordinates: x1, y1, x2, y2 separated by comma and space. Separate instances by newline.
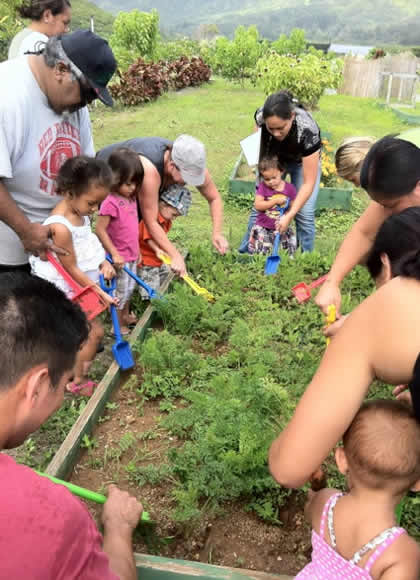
99, 193, 139, 262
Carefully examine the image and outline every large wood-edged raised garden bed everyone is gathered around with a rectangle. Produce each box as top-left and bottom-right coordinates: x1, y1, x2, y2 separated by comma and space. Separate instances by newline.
44, 247, 418, 580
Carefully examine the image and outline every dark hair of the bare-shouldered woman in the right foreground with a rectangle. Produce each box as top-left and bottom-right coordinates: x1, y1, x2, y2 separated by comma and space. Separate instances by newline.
366, 207, 420, 280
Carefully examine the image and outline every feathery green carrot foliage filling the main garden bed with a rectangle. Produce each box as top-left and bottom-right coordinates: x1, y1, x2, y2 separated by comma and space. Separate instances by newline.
132, 247, 370, 522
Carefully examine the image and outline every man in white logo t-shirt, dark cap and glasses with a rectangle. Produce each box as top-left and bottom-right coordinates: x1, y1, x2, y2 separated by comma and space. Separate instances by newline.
0, 30, 116, 271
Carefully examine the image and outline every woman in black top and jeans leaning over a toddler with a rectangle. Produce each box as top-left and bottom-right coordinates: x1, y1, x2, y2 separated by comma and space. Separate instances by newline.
239, 91, 321, 252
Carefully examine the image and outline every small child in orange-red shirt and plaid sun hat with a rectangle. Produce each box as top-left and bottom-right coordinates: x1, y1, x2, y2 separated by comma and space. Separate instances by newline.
139, 185, 191, 300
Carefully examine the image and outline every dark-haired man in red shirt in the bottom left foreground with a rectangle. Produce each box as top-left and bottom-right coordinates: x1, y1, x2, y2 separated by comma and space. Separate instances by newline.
0, 272, 142, 580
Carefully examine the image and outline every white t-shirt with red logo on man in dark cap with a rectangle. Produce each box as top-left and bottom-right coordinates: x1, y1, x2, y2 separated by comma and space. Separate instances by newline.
0, 56, 95, 265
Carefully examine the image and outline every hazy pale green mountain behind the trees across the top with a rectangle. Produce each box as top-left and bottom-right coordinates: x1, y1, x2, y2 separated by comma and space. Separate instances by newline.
89, 0, 420, 45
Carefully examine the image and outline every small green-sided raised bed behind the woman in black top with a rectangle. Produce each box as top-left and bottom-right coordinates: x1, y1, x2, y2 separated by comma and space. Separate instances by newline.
229, 153, 353, 211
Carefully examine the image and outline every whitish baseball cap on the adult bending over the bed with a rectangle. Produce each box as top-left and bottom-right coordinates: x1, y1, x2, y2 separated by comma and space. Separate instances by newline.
171, 135, 206, 186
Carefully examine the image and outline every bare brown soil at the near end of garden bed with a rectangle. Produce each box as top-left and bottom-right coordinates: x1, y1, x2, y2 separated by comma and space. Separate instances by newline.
71, 375, 310, 574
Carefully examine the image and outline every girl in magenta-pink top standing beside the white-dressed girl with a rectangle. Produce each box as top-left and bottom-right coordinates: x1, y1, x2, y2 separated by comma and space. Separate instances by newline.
96, 148, 144, 334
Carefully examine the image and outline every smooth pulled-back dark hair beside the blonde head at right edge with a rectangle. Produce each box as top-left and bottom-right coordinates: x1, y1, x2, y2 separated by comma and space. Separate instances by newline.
360, 135, 420, 200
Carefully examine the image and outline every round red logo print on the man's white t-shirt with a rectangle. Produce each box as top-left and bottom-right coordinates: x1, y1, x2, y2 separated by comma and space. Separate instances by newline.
38, 121, 81, 196
